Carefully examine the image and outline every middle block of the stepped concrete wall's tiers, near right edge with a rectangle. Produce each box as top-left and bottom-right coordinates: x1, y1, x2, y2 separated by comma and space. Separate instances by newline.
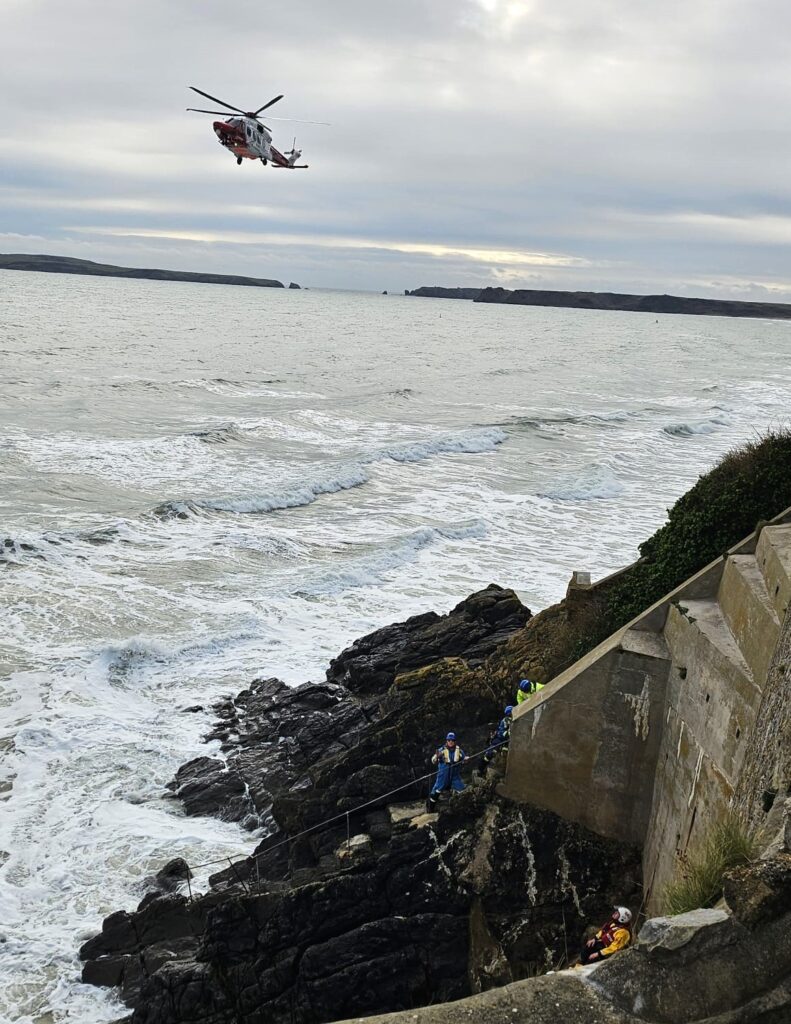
717, 555, 780, 688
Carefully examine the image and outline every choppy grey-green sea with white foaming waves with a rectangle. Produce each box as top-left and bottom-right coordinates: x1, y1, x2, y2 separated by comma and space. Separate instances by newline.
0, 272, 791, 1024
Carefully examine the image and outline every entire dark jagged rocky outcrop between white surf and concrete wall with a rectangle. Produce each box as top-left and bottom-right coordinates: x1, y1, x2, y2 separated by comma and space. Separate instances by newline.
81, 586, 639, 1024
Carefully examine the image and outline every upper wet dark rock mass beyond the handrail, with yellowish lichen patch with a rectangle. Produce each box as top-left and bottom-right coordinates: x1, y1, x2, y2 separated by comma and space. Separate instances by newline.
172, 586, 531, 839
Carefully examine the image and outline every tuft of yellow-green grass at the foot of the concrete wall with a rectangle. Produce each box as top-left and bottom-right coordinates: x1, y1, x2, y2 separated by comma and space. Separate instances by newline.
663, 815, 756, 913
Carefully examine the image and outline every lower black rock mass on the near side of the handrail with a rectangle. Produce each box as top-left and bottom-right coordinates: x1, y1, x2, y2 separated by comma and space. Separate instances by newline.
85, 785, 638, 1024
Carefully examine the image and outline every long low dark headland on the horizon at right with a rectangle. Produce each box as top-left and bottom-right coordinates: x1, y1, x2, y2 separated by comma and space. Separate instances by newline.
405, 288, 791, 319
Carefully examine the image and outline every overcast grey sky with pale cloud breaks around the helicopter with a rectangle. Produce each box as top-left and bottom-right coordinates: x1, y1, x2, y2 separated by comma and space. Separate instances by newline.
0, 0, 791, 301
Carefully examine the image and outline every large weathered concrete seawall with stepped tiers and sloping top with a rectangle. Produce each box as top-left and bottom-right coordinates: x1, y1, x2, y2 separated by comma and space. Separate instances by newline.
502, 509, 791, 913
